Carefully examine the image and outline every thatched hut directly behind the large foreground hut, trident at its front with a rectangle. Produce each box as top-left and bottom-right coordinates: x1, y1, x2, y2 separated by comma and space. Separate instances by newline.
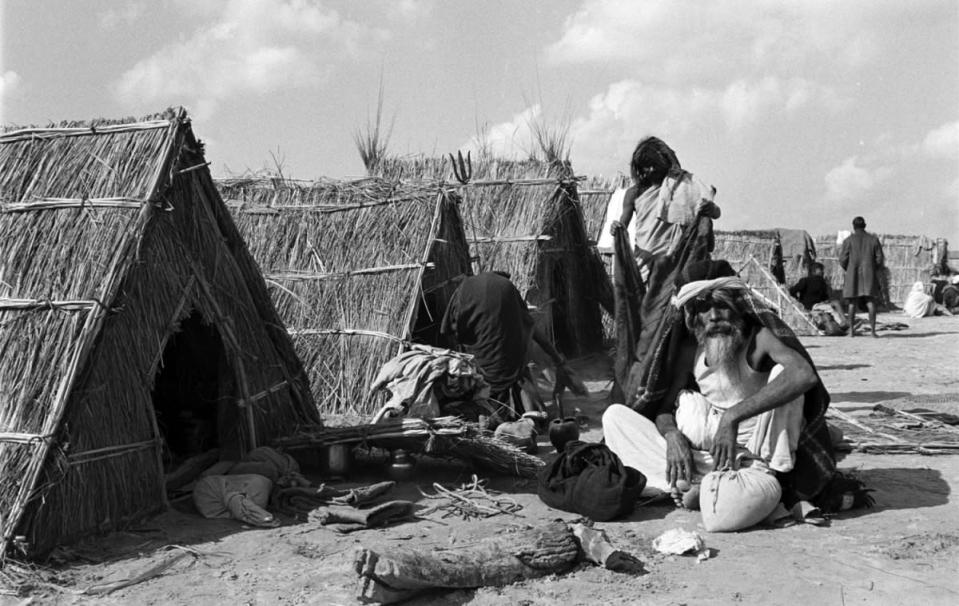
218, 178, 471, 417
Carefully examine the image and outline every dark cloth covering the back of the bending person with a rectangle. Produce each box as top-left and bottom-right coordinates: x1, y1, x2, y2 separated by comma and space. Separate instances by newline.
441, 272, 533, 393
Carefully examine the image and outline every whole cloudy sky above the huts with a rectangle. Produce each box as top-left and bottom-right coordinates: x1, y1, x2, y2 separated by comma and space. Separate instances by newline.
0, 0, 959, 248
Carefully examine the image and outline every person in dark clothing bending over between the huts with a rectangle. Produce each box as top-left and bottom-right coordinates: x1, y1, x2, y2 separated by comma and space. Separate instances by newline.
440, 272, 568, 414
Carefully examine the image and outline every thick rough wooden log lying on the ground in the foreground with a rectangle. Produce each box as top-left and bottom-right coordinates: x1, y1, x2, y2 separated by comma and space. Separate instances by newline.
353, 522, 581, 604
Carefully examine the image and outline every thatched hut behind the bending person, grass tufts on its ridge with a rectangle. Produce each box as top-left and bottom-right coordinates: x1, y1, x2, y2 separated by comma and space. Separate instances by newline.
377, 156, 611, 356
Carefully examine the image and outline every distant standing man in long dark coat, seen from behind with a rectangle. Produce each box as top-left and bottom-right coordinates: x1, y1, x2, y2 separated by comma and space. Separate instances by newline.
839, 217, 884, 337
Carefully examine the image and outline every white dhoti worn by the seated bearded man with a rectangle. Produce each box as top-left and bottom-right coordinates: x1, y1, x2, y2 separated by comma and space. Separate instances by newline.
603, 365, 803, 496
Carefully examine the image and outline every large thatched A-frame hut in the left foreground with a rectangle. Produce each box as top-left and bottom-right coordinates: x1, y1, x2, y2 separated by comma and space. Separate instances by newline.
0, 110, 319, 556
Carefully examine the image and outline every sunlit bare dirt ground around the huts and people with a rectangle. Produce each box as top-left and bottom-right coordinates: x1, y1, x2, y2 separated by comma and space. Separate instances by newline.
7, 314, 959, 606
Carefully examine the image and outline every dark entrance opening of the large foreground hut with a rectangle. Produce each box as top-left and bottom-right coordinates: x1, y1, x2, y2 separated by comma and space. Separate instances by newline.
153, 311, 234, 471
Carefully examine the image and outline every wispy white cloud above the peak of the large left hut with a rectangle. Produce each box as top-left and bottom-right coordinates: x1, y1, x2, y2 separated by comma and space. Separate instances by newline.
114, 0, 385, 115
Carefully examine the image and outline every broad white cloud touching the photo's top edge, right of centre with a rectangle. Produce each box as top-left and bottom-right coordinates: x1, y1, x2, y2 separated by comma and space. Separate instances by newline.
546, 0, 900, 83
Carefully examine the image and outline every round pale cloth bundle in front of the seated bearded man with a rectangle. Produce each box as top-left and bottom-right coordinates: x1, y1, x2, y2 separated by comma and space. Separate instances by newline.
699, 461, 782, 532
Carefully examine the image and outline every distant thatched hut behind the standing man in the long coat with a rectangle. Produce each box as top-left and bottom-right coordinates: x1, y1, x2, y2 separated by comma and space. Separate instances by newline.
816, 234, 949, 309
